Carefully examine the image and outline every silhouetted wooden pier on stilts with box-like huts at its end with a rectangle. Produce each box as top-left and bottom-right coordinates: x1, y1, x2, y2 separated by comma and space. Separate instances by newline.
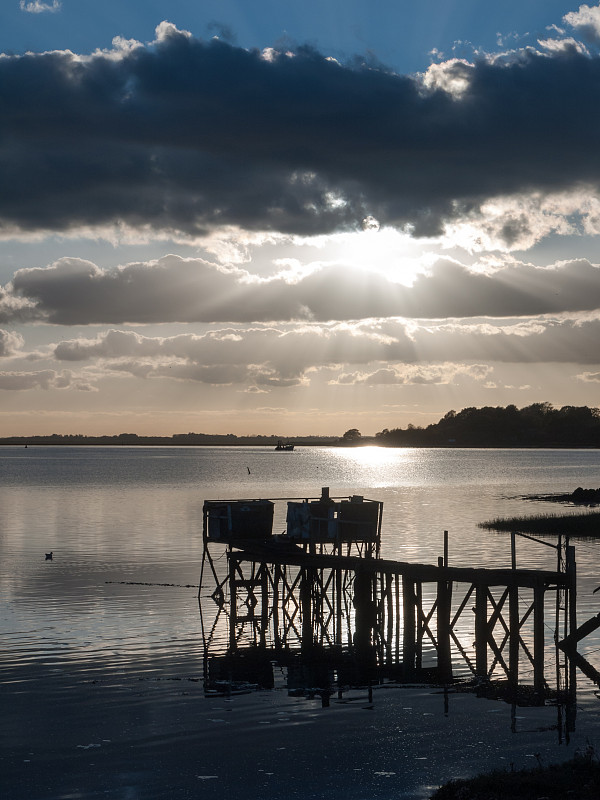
201, 489, 576, 700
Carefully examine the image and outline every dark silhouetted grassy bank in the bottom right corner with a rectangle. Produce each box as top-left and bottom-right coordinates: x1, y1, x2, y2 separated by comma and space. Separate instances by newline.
431, 748, 600, 800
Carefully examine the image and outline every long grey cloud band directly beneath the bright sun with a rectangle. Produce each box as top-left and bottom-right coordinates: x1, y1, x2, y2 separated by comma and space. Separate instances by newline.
7, 255, 600, 325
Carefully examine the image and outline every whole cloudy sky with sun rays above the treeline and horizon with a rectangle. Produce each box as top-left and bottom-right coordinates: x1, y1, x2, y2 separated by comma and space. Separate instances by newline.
0, 0, 600, 437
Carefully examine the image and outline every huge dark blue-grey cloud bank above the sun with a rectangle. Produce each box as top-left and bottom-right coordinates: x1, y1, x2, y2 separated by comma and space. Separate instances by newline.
0, 23, 600, 235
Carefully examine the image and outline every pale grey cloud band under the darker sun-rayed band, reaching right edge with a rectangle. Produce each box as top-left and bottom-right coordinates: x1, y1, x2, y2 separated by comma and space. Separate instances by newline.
44, 317, 600, 391
